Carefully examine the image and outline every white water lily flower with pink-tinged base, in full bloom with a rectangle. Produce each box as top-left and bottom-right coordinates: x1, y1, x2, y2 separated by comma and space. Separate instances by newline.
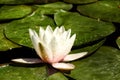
11, 26, 87, 70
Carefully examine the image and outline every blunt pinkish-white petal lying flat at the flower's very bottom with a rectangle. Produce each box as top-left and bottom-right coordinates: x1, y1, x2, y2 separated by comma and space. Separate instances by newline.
52, 63, 75, 70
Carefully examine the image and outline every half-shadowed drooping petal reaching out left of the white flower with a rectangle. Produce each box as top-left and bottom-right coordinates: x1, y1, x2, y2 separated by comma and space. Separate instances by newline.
11, 58, 41, 64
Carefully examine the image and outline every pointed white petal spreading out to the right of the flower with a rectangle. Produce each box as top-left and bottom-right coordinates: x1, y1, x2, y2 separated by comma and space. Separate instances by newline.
63, 52, 87, 61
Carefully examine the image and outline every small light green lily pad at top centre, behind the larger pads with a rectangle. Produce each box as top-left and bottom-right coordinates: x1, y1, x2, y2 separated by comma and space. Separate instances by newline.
35, 2, 72, 15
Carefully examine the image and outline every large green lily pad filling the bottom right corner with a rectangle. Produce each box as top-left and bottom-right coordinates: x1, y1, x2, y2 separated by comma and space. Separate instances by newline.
69, 46, 120, 80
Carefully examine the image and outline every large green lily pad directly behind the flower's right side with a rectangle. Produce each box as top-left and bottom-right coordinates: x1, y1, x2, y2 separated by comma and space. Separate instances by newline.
54, 10, 115, 46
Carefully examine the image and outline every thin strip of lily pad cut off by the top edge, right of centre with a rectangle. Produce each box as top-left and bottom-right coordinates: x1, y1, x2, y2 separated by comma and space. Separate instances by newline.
64, 0, 98, 4
